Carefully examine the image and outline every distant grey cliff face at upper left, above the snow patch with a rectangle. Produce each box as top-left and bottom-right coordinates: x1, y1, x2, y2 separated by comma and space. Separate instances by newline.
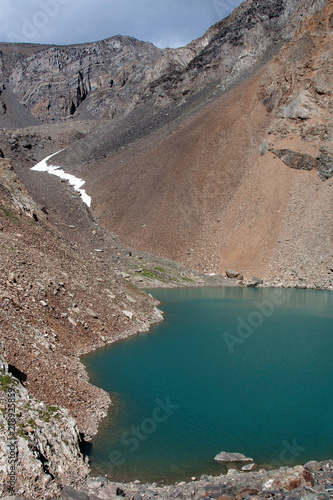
4, 37, 160, 120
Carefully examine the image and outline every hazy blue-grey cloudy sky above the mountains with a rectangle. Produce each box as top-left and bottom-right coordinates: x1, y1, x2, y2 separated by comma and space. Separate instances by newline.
0, 0, 241, 48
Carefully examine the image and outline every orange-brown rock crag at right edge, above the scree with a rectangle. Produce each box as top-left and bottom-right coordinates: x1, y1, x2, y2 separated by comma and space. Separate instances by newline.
259, 1, 333, 180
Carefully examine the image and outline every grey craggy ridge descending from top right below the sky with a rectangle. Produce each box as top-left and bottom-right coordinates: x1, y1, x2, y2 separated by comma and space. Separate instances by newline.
144, 0, 325, 105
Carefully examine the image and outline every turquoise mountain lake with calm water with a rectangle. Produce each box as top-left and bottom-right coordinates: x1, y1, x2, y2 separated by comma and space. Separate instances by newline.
83, 288, 333, 482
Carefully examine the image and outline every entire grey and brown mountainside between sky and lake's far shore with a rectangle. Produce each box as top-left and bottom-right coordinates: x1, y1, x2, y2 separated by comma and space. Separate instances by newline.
3, 0, 332, 292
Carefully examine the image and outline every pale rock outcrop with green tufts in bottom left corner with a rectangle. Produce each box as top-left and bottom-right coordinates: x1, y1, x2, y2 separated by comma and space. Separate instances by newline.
0, 356, 89, 496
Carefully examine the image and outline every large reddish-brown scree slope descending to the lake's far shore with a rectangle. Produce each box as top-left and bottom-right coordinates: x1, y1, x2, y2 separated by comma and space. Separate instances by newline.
81, 2, 333, 287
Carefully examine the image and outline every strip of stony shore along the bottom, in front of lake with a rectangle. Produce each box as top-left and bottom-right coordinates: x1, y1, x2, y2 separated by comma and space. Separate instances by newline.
61, 460, 333, 500
